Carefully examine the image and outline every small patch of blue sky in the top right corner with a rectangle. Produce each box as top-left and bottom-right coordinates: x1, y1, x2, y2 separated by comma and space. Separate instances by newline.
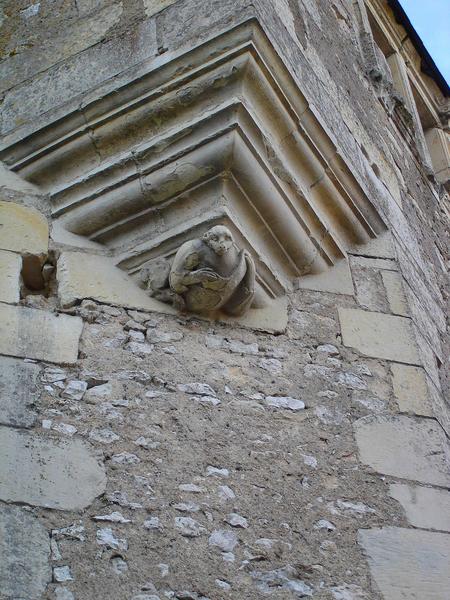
400, 0, 450, 82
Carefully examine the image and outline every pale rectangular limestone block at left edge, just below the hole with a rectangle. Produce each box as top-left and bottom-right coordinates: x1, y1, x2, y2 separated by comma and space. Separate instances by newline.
0, 304, 83, 364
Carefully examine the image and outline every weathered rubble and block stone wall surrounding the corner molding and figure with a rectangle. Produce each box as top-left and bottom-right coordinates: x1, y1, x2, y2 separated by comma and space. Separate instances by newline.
0, 0, 450, 600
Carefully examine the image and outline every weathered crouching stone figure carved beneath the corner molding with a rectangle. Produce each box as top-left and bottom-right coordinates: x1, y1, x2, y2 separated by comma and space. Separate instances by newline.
169, 225, 255, 316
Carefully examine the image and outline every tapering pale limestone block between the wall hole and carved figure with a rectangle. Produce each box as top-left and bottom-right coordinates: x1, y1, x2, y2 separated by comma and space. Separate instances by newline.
57, 252, 175, 314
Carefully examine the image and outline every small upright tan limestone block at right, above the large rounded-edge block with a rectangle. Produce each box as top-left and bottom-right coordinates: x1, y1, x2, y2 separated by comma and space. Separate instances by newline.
391, 363, 433, 417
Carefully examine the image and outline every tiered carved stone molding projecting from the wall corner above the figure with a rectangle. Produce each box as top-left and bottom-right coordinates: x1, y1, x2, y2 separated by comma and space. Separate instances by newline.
0, 21, 385, 314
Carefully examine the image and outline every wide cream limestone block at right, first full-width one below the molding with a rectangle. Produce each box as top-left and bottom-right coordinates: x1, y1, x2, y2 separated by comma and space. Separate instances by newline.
339, 308, 420, 365
